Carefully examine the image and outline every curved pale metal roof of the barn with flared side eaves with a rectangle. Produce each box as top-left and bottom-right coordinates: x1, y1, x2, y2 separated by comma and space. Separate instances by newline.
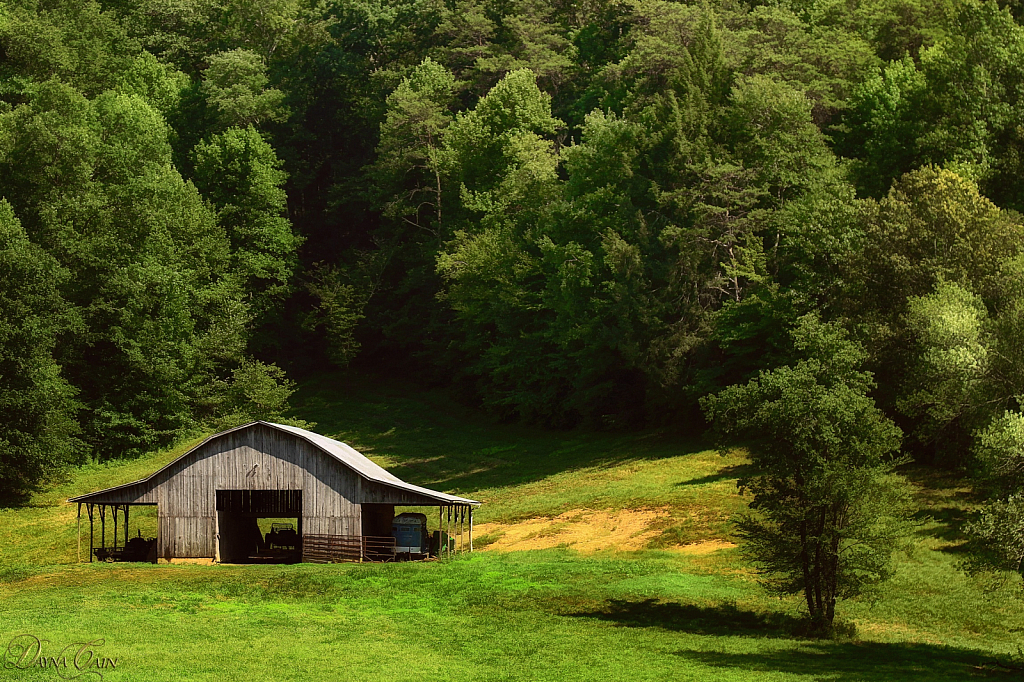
68, 421, 480, 506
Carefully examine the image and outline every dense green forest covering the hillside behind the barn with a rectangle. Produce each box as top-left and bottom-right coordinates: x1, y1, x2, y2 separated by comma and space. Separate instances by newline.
0, 0, 1024, 593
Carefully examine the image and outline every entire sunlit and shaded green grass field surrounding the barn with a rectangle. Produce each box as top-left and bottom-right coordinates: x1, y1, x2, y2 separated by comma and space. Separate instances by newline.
0, 377, 1024, 682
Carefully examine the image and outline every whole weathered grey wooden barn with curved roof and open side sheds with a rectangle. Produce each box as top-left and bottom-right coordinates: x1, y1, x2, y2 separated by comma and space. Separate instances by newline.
69, 421, 480, 563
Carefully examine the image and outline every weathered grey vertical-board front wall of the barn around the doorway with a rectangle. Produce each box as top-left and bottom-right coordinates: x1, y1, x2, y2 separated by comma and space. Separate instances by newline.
146, 424, 361, 558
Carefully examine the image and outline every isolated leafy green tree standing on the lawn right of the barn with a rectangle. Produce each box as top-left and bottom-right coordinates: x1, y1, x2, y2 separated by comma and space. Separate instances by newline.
701, 315, 907, 633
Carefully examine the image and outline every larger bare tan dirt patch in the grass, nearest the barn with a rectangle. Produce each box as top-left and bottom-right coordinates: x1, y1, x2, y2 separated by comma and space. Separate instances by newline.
476, 509, 669, 554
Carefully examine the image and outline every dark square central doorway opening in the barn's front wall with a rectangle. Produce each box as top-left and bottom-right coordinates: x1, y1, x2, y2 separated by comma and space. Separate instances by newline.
211, 491, 302, 563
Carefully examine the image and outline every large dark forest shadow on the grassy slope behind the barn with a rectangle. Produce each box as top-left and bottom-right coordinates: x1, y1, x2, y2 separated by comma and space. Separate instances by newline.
284, 372, 708, 493
